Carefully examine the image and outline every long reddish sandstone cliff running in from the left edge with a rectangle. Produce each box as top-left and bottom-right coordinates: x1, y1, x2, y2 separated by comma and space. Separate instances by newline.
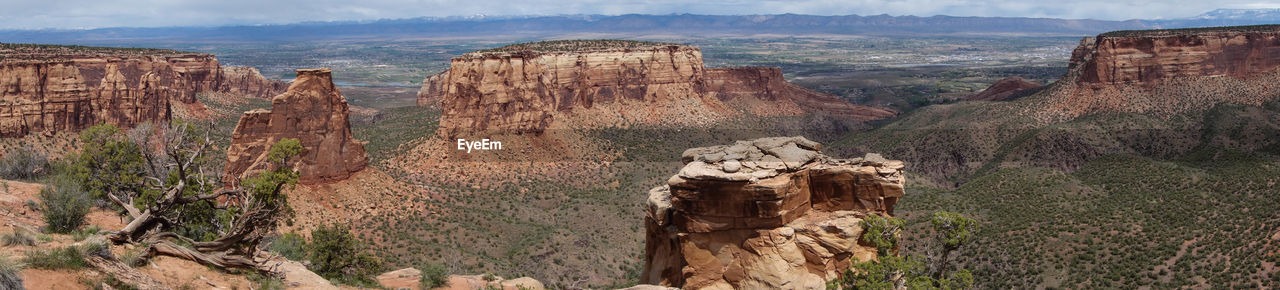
0, 43, 282, 137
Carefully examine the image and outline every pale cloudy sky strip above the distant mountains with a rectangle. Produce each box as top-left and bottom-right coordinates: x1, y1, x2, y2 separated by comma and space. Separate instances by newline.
0, 0, 1280, 29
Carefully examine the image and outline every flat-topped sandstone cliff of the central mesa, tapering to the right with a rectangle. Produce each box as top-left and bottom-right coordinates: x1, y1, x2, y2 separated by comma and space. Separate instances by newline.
419, 41, 896, 135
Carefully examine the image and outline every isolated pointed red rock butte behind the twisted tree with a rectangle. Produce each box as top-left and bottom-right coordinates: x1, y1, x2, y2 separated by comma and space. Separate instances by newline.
223, 69, 369, 184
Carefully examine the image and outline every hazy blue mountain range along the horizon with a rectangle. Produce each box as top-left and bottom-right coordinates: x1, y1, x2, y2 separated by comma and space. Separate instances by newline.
0, 9, 1280, 43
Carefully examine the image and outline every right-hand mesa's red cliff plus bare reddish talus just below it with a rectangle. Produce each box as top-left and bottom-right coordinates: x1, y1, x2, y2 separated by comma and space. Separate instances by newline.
1039, 26, 1280, 120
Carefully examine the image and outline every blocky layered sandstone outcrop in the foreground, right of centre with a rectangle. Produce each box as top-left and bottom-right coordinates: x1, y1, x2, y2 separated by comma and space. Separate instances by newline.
640, 137, 905, 289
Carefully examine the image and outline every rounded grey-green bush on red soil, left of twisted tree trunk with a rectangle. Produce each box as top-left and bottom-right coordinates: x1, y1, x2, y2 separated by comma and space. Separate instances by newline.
40, 176, 93, 234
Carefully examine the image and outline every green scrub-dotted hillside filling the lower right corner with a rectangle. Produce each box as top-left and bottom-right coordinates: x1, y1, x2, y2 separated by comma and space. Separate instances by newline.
900, 147, 1280, 289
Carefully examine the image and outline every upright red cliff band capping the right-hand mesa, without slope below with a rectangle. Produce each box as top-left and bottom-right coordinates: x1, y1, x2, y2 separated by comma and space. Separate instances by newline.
1071, 26, 1280, 84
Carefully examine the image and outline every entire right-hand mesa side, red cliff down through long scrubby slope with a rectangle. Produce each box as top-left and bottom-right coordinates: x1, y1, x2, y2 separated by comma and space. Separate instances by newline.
833, 26, 1280, 184
